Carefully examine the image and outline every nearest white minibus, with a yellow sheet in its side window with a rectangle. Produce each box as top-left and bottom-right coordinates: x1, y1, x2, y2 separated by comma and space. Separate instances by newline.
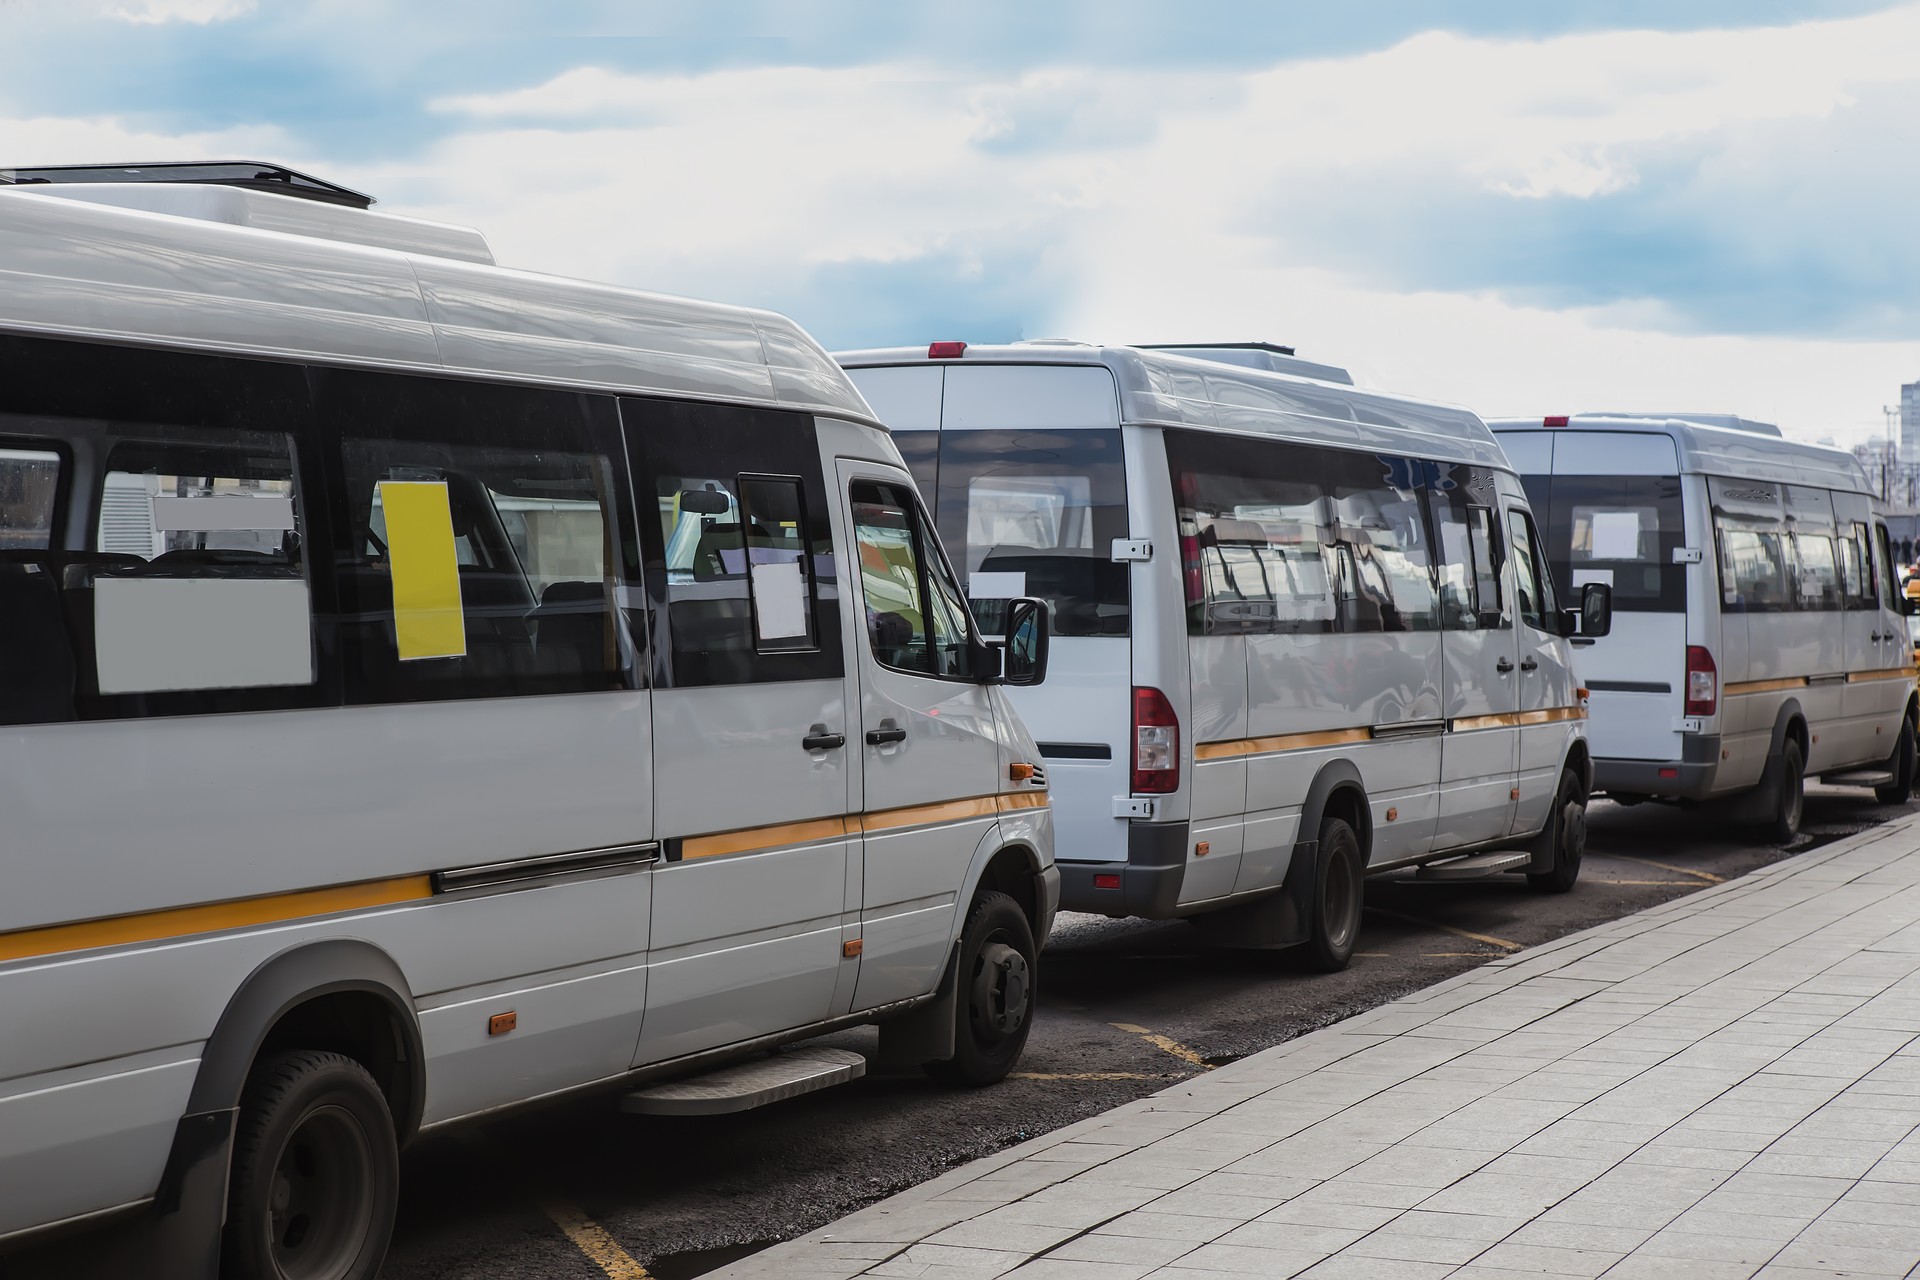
0, 165, 1058, 1280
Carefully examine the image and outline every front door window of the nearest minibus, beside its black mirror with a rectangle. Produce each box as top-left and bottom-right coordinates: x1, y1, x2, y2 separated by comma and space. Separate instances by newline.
851, 480, 970, 677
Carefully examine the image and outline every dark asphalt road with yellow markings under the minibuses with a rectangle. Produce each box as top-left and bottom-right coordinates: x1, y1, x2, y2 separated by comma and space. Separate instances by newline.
11, 787, 1901, 1280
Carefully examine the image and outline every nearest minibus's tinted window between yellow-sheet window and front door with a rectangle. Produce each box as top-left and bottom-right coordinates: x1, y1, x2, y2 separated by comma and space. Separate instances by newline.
620, 397, 845, 685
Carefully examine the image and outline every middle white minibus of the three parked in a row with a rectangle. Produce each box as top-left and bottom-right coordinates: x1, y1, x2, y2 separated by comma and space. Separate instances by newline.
837, 342, 1609, 969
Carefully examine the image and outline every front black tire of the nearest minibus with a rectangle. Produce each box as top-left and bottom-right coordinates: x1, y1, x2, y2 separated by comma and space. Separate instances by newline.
925, 890, 1039, 1086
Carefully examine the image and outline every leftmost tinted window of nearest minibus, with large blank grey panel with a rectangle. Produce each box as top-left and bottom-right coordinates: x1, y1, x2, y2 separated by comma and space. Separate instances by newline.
0, 338, 336, 723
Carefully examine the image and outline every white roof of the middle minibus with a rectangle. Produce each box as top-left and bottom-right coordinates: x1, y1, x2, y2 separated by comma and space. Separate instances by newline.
833, 342, 1513, 470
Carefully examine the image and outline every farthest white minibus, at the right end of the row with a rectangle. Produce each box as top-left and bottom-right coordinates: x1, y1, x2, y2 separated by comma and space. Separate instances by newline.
1492, 415, 1920, 842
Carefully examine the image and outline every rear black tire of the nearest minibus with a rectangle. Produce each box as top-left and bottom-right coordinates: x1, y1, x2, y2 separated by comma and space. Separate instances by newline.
221, 1050, 399, 1280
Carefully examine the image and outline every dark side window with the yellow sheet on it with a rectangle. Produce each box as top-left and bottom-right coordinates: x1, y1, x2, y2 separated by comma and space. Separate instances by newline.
317, 370, 634, 702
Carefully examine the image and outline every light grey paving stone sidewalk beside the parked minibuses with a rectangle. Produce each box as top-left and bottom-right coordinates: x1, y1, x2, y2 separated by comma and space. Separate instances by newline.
718, 818, 1920, 1280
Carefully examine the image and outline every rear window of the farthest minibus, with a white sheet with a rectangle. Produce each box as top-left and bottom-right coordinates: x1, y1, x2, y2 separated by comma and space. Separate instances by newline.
1526, 476, 1686, 612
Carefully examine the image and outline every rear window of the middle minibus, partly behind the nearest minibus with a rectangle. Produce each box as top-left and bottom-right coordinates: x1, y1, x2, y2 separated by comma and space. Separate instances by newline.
895, 430, 1129, 635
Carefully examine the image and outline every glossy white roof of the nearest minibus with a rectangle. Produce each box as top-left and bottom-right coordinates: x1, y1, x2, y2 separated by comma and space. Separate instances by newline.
0, 184, 874, 422
